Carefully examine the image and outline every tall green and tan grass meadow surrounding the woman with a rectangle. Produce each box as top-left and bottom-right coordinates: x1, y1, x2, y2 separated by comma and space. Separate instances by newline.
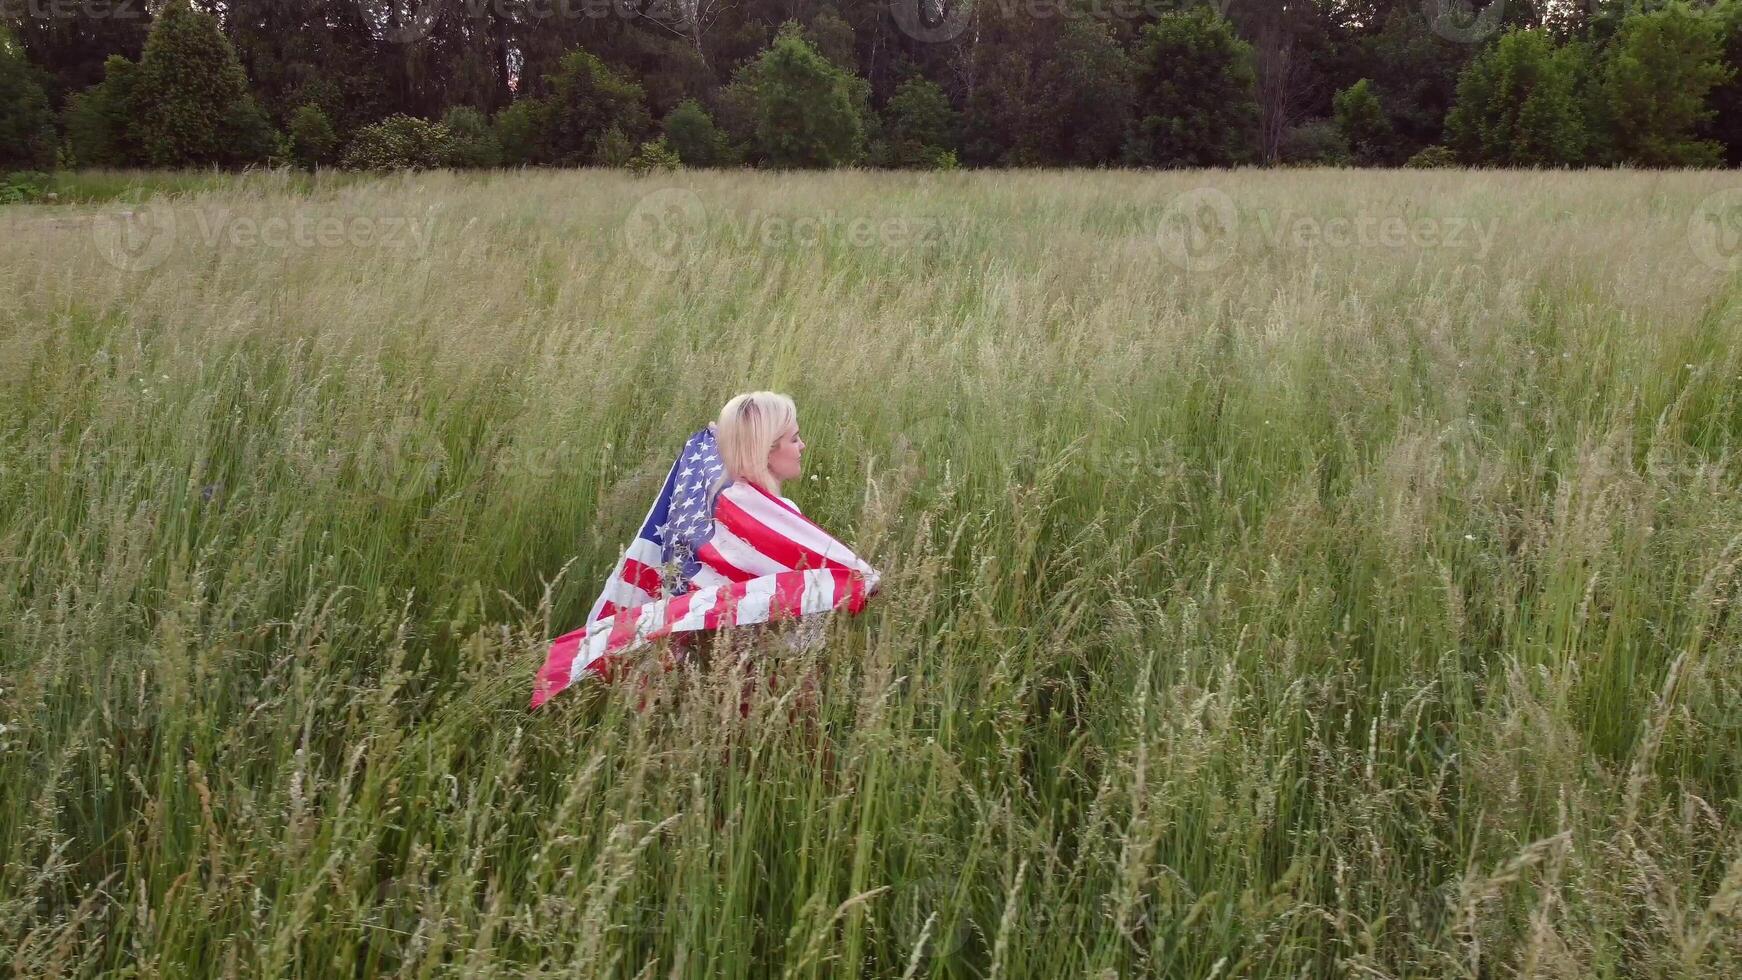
0, 171, 1742, 978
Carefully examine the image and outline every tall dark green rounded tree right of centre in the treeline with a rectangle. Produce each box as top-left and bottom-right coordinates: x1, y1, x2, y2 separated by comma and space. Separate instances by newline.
1125, 7, 1258, 167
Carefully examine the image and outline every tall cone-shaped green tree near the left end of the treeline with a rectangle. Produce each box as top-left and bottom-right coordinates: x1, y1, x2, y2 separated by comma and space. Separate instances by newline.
132, 0, 273, 167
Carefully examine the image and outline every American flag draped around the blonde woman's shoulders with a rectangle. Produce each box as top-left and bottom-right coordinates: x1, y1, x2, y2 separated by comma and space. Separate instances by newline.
531, 426, 878, 708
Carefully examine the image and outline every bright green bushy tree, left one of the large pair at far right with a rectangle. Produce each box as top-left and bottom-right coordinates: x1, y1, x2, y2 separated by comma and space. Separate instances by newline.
1446, 30, 1587, 167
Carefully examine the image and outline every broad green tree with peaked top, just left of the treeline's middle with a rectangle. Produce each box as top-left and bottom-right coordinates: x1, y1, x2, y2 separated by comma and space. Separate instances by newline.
732, 23, 869, 169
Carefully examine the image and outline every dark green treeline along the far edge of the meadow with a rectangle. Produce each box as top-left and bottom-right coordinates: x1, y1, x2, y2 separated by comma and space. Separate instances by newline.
0, 0, 1742, 169
